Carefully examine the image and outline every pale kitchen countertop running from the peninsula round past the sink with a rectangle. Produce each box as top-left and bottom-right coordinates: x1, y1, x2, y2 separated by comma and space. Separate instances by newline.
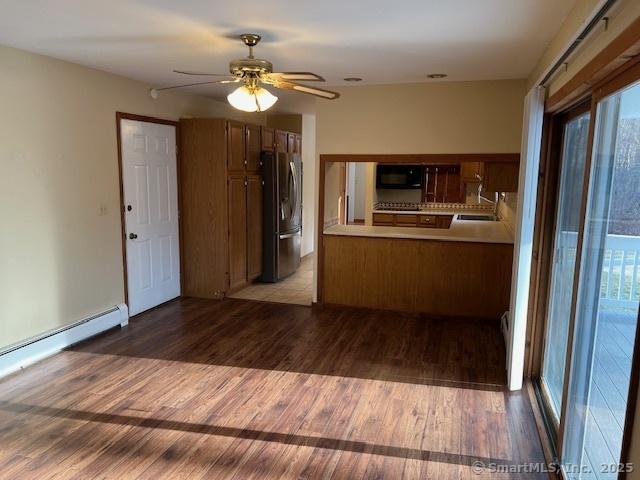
324, 214, 513, 244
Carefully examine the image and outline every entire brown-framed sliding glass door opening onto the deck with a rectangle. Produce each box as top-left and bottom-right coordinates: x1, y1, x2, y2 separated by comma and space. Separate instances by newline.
537, 64, 640, 480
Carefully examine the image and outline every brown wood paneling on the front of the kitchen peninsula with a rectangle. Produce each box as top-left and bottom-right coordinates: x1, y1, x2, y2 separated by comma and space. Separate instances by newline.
322, 235, 513, 318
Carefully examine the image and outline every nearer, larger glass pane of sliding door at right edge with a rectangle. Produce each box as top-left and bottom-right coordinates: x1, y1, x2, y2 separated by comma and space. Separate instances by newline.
562, 80, 640, 480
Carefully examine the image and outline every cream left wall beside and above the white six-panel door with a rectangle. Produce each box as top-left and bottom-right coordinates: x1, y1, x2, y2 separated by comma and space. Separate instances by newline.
0, 47, 260, 348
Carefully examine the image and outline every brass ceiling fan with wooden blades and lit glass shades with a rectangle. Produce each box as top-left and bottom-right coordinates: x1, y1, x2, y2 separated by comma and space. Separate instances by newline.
149, 33, 340, 112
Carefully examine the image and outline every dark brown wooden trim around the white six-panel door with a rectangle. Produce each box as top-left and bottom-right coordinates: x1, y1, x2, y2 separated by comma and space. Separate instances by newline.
116, 111, 184, 305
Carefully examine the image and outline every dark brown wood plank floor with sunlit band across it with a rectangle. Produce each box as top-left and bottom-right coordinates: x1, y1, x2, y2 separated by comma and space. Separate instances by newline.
0, 299, 546, 480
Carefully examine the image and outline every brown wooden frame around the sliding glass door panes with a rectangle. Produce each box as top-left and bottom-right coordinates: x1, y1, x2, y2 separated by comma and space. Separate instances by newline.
529, 58, 640, 479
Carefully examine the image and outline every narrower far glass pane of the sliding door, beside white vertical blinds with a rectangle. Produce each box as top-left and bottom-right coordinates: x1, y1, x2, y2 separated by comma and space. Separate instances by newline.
540, 112, 590, 423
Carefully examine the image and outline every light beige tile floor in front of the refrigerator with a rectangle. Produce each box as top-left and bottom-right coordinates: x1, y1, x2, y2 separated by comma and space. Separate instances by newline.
229, 254, 314, 305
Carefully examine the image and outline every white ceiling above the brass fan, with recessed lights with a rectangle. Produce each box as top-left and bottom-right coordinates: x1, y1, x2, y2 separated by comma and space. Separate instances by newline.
0, 0, 575, 110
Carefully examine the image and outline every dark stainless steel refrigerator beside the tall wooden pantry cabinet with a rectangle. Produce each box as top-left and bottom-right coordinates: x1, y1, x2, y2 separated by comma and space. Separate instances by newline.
260, 152, 302, 282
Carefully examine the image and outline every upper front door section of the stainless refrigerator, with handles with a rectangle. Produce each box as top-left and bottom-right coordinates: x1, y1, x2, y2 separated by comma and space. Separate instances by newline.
278, 153, 302, 232
